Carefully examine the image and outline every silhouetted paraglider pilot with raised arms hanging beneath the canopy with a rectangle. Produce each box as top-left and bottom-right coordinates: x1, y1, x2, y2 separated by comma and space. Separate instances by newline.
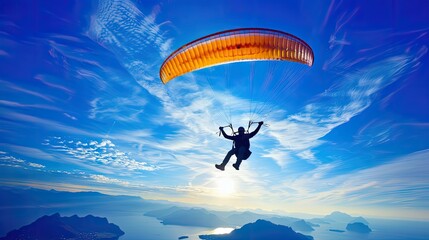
215, 122, 264, 171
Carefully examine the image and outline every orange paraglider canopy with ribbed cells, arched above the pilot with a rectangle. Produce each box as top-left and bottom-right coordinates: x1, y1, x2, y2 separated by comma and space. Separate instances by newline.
159, 28, 314, 84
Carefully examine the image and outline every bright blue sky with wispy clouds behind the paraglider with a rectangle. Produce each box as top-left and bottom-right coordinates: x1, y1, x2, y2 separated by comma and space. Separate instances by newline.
0, 0, 429, 219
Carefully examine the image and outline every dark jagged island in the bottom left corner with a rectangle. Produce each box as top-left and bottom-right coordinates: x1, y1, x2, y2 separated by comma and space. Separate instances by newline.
0, 213, 124, 240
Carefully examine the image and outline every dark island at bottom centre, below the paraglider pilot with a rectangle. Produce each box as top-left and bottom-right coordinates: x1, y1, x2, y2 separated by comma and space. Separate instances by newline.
199, 220, 313, 240
